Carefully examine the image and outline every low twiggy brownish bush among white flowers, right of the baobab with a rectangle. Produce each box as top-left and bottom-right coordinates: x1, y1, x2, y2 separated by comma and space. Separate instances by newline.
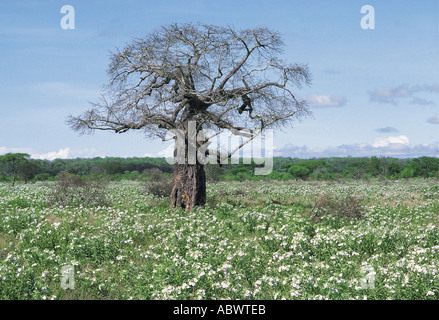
312, 194, 364, 223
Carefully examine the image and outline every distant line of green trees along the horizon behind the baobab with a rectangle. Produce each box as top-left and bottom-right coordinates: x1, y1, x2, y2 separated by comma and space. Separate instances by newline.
0, 153, 439, 185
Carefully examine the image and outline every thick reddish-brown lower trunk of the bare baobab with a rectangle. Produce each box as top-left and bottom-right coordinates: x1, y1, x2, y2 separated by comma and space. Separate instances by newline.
170, 162, 206, 211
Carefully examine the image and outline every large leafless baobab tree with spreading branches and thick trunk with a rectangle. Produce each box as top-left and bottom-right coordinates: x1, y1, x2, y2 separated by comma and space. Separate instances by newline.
68, 24, 310, 210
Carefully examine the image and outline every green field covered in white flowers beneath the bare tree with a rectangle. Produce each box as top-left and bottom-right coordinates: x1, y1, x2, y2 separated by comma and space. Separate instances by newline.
0, 180, 439, 300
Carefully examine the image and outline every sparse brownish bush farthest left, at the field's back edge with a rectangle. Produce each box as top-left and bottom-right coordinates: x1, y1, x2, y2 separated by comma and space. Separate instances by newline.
49, 172, 108, 207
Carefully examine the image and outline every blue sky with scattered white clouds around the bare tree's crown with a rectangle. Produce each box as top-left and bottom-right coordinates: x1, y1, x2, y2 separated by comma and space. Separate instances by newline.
0, 0, 439, 159
